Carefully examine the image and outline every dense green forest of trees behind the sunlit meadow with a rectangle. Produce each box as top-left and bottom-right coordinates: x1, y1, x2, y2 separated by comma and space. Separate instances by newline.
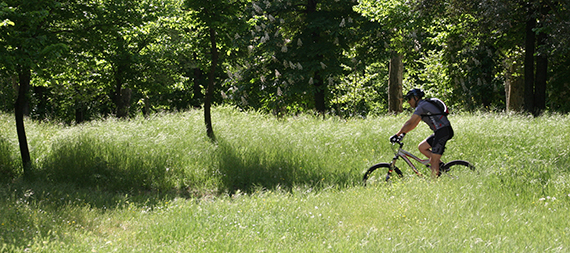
0, 0, 570, 178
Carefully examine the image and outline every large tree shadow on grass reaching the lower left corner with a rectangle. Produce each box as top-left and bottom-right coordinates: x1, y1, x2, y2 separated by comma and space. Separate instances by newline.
0, 136, 184, 252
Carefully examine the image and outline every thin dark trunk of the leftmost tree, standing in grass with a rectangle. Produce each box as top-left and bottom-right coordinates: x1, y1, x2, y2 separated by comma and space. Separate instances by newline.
14, 66, 32, 178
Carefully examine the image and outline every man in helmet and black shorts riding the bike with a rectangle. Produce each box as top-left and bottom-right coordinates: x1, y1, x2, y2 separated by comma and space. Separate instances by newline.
390, 89, 453, 178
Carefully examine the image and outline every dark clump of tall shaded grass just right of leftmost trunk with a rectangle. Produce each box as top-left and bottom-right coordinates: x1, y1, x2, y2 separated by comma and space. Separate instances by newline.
34, 136, 178, 194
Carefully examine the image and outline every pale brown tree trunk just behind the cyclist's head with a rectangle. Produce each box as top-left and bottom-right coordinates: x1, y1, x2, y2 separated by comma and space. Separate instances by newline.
388, 53, 404, 114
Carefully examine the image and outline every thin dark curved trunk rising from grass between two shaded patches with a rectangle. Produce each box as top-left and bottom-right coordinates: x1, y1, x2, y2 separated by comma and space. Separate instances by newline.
204, 27, 218, 141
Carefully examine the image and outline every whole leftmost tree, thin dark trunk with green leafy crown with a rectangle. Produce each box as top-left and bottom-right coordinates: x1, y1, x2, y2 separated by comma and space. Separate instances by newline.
0, 0, 73, 177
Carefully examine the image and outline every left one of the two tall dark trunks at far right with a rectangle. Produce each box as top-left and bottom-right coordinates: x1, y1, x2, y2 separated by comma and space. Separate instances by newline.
524, 7, 536, 112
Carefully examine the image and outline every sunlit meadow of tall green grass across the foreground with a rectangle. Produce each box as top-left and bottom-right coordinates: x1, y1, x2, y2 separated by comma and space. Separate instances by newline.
0, 107, 570, 252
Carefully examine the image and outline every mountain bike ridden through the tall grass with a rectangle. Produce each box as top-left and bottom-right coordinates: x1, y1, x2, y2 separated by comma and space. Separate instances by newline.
362, 134, 475, 185
